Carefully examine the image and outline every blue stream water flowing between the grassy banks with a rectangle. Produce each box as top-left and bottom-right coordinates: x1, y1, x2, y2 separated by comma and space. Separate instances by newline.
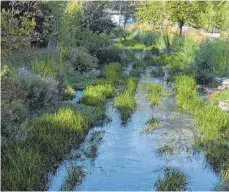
49, 66, 219, 191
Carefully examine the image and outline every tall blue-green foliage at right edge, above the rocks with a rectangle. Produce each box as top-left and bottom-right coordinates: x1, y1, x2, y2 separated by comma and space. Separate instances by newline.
195, 40, 229, 77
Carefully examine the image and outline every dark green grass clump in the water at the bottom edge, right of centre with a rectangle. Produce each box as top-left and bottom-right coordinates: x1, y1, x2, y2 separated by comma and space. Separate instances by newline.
154, 168, 188, 191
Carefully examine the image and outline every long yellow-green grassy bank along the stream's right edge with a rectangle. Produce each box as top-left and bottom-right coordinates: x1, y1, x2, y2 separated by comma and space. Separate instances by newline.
175, 75, 229, 182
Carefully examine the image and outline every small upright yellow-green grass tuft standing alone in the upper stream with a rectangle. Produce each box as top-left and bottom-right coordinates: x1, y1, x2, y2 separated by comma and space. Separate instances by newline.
147, 83, 162, 106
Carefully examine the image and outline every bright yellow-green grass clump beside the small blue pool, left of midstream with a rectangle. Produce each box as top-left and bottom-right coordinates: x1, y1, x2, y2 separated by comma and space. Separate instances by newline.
82, 84, 114, 106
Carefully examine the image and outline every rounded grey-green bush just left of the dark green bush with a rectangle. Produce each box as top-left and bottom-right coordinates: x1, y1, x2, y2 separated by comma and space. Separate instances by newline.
70, 47, 98, 72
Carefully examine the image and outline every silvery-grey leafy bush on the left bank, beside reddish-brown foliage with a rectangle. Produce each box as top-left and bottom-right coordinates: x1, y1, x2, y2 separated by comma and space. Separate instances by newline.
15, 68, 58, 105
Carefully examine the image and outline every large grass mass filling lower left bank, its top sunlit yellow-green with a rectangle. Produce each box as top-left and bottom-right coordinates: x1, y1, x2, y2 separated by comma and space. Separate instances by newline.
2, 108, 89, 191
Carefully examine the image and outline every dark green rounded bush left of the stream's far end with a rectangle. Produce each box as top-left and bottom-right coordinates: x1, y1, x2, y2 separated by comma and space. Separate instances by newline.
96, 46, 122, 64
